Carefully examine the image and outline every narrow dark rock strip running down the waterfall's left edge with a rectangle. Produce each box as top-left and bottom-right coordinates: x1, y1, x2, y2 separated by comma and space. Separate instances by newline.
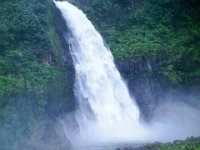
48, 2, 76, 116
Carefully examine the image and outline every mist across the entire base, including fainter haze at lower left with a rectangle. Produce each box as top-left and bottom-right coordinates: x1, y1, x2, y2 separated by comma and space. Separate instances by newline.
2, 91, 200, 150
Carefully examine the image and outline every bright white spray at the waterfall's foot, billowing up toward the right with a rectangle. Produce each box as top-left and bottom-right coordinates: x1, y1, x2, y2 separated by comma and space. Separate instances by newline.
59, 92, 200, 147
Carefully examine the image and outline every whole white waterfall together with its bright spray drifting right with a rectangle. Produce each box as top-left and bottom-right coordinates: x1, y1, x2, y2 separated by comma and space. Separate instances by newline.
55, 1, 200, 147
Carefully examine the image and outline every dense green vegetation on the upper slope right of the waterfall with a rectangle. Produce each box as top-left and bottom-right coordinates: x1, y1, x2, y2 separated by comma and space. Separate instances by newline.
77, 0, 200, 86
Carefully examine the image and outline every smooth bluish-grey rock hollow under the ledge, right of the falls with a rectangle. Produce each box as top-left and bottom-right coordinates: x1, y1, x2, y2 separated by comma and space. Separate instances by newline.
128, 74, 163, 121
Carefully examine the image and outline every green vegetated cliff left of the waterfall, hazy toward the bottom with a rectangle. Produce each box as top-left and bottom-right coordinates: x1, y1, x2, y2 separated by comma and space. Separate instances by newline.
0, 0, 73, 150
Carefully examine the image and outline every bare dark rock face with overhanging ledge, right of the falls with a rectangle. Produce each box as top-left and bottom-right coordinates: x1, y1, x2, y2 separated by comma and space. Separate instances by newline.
116, 58, 167, 121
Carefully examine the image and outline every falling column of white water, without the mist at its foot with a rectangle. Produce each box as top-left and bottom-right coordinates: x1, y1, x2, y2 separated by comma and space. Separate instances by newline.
55, 1, 144, 143
